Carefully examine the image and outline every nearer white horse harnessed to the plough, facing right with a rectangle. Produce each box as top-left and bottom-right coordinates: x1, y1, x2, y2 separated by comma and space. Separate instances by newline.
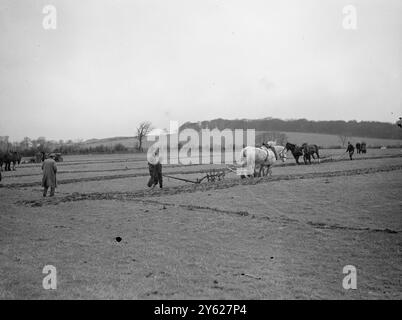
240, 145, 276, 179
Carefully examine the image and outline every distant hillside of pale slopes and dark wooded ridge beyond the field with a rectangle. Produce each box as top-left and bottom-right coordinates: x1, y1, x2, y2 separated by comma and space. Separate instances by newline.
80, 118, 402, 149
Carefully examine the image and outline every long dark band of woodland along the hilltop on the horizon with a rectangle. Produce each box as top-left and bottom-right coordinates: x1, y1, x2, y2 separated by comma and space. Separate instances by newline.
180, 118, 402, 140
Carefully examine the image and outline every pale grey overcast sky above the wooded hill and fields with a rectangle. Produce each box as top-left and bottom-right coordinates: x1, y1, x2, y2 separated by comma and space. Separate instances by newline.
0, 0, 402, 140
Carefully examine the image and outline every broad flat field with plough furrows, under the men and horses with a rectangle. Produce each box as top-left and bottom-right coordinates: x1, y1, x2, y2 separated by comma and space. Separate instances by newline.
0, 149, 402, 299
